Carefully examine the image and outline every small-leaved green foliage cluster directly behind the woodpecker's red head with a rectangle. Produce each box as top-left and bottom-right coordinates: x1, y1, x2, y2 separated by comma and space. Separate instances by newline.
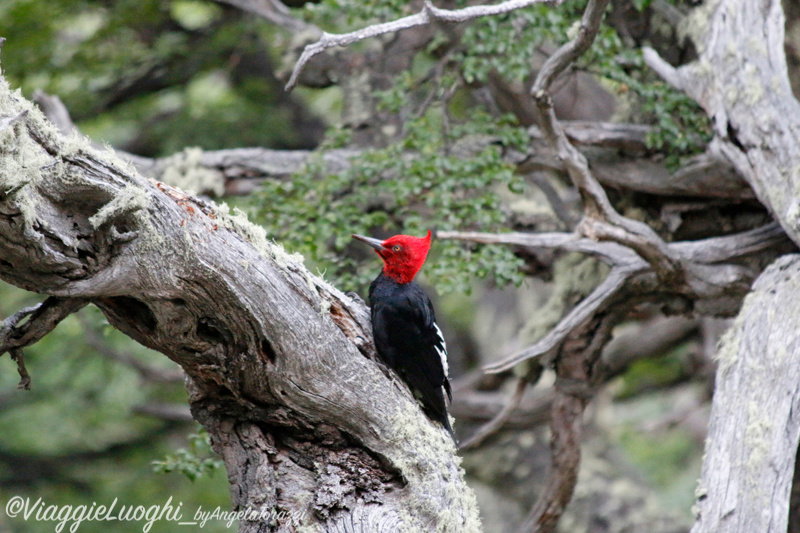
258, 106, 527, 292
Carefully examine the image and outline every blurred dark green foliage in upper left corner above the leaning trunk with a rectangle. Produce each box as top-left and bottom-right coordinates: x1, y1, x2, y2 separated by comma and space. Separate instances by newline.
0, 0, 322, 156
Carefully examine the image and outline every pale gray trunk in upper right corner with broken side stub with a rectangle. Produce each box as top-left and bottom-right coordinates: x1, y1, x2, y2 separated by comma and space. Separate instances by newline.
644, 0, 800, 243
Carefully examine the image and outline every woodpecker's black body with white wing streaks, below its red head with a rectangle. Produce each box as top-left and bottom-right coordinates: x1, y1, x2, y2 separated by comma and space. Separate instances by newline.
369, 272, 453, 435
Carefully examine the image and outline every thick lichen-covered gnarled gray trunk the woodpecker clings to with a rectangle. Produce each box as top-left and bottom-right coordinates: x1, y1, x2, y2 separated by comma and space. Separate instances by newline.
0, 61, 480, 532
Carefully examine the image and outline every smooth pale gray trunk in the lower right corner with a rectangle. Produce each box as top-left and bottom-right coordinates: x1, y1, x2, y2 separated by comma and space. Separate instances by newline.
692, 255, 800, 533
